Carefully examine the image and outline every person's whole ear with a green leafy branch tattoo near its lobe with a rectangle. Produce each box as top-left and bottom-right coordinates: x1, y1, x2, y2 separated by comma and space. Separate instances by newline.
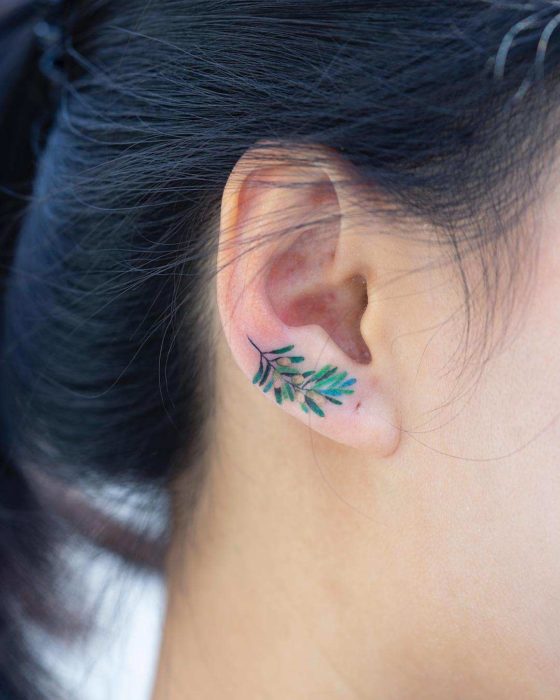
217, 145, 400, 456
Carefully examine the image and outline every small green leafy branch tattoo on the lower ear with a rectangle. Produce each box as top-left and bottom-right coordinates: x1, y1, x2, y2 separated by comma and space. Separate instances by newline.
247, 336, 356, 418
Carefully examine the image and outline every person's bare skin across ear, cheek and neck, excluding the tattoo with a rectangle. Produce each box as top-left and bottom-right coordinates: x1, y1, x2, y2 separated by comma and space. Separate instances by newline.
153, 145, 560, 700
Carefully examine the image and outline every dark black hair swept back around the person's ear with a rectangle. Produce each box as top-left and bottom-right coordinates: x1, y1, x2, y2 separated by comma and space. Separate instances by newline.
0, 0, 560, 700
